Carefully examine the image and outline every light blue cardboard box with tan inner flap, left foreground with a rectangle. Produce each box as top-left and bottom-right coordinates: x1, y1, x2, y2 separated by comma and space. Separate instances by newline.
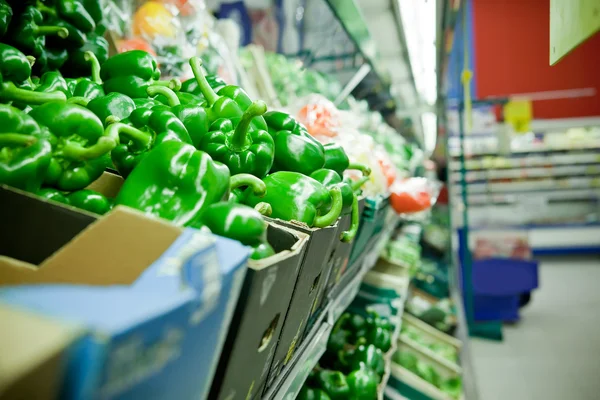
0, 187, 248, 399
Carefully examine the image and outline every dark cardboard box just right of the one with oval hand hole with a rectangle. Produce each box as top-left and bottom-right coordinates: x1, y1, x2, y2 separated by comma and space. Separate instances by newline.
265, 218, 338, 389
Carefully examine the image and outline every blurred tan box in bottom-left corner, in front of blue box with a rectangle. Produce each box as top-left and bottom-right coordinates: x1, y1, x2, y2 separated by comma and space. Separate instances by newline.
0, 304, 84, 400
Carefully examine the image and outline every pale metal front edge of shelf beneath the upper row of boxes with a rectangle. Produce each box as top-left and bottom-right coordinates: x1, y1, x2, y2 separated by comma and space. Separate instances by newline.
263, 219, 397, 400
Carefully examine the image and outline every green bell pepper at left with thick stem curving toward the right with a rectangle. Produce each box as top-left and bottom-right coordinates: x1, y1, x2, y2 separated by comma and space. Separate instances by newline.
29, 102, 119, 191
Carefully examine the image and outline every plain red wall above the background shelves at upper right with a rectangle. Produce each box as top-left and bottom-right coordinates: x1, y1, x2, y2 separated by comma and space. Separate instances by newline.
471, 0, 600, 118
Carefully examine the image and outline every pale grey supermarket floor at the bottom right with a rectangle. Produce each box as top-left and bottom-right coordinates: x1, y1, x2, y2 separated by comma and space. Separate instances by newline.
471, 257, 600, 400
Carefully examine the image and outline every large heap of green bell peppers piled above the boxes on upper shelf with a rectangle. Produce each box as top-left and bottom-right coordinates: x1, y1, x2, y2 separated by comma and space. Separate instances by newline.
0, 44, 370, 259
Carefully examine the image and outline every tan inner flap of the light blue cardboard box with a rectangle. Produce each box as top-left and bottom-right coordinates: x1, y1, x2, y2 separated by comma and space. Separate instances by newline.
0, 207, 182, 285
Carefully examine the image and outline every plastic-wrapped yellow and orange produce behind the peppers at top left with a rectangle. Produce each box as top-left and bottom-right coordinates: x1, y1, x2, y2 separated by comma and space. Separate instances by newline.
106, 0, 238, 84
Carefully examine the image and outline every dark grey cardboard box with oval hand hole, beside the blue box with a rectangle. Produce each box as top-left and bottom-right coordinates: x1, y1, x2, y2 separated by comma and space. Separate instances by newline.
209, 223, 308, 400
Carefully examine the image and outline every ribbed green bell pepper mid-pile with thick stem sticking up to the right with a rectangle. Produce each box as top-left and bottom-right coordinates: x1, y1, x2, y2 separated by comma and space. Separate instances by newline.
199, 101, 275, 178
